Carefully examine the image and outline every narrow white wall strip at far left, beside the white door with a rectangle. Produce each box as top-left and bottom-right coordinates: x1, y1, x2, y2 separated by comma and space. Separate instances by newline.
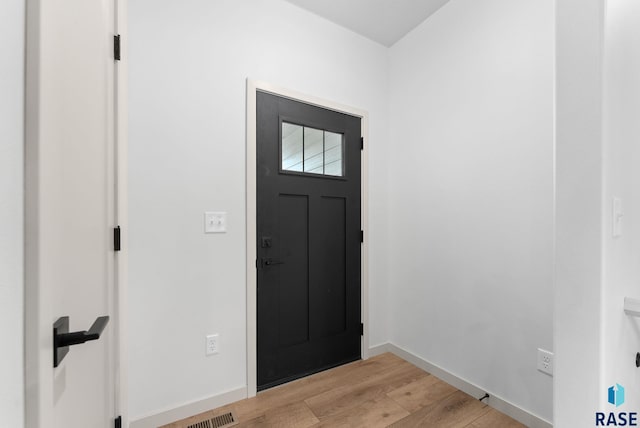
0, 0, 25, 427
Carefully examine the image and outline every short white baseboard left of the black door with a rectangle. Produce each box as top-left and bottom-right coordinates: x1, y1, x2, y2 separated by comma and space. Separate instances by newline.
129, 387, 247, 428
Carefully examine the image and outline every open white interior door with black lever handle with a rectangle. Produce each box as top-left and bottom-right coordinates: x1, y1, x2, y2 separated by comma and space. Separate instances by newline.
26, 0, 117, 428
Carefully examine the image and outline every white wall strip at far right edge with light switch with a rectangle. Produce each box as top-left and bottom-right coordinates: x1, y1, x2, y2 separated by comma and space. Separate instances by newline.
599, 0, 640, 412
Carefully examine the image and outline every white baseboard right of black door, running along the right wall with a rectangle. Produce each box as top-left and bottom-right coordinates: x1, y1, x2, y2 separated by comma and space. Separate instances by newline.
369, 343, 553, 428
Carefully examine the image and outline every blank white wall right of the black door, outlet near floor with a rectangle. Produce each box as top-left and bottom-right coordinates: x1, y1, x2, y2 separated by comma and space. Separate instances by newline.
389, 0, 554, 420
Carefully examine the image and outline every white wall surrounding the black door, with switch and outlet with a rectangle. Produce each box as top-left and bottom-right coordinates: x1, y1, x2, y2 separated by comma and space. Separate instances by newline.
128, 0, 388, 420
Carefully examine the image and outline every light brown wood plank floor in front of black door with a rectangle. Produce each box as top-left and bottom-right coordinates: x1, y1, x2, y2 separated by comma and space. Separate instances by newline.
163, 353, 524, 428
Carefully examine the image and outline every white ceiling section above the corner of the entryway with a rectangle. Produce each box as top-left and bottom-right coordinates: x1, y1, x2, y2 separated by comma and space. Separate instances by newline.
287, 0, 449, 46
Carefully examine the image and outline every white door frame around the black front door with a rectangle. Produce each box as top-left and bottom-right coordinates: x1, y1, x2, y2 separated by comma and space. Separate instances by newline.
246, 79, 369, 397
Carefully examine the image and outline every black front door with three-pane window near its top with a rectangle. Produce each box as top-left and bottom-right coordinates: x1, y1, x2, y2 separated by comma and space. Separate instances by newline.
256, 92, 361, 390
